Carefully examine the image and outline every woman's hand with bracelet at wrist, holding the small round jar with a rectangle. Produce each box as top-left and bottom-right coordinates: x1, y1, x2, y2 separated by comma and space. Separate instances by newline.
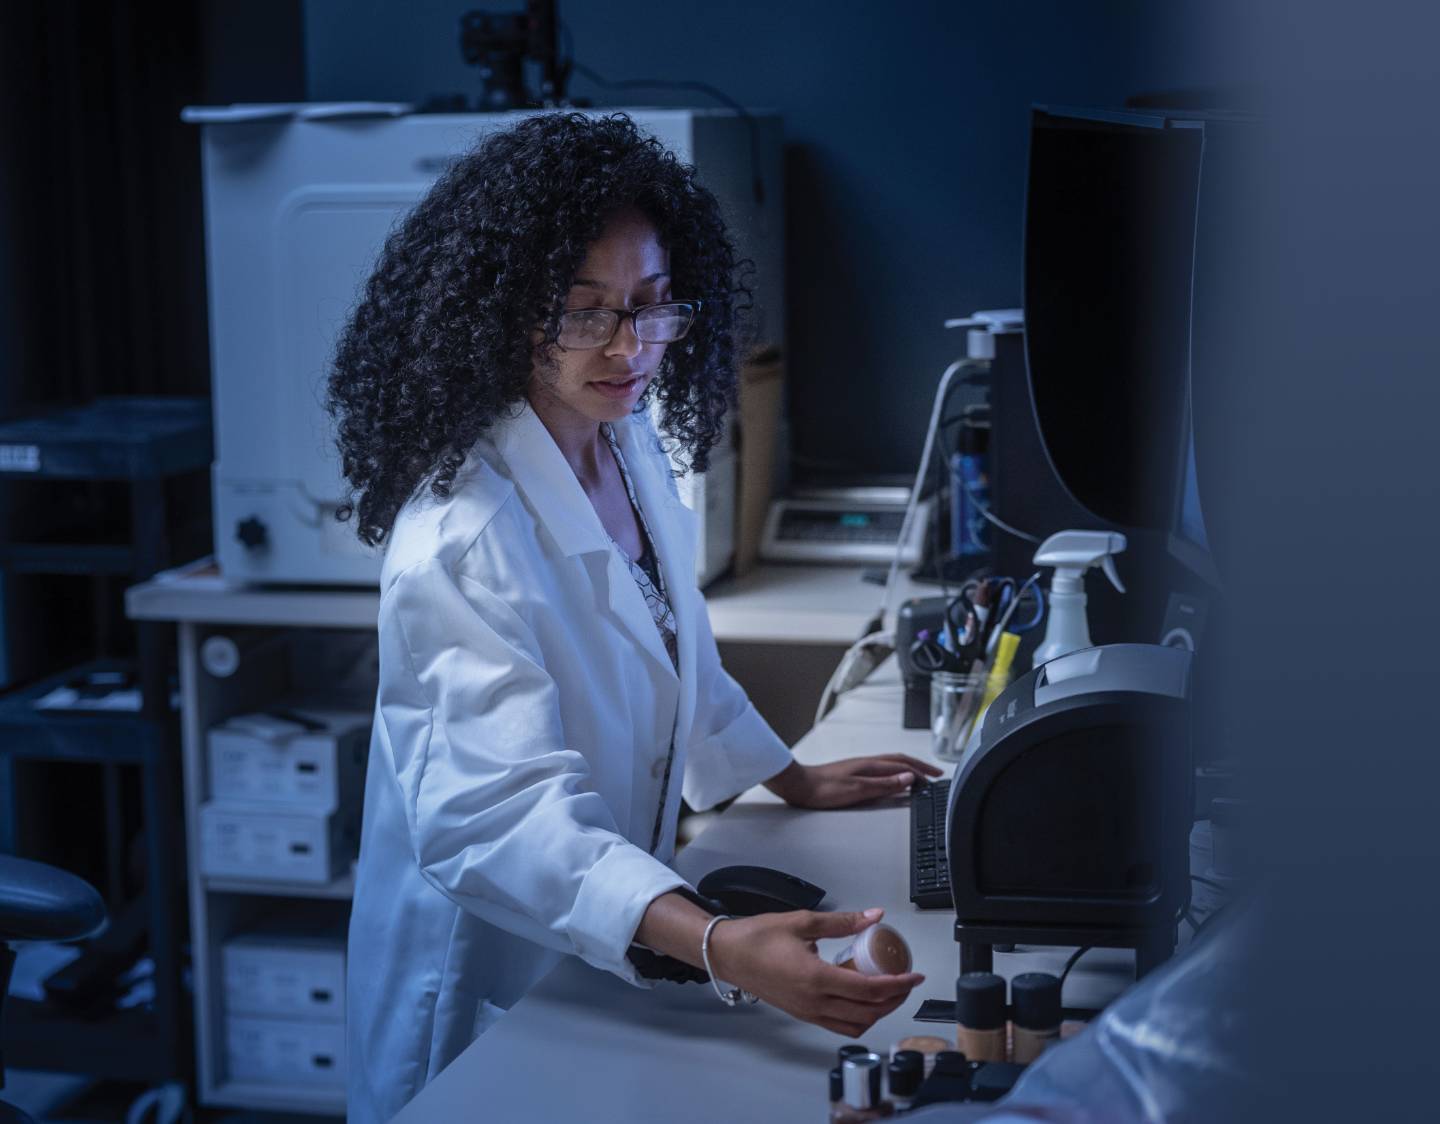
710, 910, 924, 1038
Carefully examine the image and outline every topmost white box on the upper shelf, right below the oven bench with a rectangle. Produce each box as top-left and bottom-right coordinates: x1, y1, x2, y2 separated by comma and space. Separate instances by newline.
207, 702, 372, 807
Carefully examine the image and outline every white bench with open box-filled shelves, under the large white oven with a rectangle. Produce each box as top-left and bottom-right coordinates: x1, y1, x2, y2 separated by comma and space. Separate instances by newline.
127, 560, 877, 1115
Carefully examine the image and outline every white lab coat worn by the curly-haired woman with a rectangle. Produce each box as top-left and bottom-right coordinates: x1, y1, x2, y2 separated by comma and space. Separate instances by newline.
347, 406, 792, 1124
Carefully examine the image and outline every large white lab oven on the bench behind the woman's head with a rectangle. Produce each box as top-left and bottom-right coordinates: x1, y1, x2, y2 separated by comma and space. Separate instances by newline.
186, 105, 785, 584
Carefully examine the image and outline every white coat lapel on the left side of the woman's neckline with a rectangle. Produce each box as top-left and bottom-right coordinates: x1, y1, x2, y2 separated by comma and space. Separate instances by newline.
492, 403, 678, 678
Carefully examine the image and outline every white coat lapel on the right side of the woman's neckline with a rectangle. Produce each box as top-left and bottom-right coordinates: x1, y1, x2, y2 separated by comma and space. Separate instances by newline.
615, 416, 704, 728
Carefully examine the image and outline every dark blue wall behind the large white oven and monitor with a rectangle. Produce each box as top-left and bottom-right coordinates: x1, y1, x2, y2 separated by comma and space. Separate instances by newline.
305, 0, 1208, 472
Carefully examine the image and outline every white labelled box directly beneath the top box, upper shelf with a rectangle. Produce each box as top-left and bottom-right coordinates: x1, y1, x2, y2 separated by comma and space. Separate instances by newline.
200, 800, 360, 882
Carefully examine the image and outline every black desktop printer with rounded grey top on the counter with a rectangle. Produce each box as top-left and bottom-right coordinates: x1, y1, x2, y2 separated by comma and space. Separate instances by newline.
946, 643, 1194, 976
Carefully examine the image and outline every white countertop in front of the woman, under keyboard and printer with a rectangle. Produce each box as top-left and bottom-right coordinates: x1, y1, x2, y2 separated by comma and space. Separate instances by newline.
396, 659, 1135, 1124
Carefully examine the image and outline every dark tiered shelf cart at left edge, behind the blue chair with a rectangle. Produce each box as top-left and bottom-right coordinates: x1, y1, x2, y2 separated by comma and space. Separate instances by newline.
0, 397, 212, 1084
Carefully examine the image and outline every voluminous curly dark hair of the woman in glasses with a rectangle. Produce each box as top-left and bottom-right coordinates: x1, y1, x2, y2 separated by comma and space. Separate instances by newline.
327, 112, 749, 545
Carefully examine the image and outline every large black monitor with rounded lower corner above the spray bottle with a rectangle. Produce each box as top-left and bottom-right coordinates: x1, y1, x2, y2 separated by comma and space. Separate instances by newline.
1025, 109, 1204, 532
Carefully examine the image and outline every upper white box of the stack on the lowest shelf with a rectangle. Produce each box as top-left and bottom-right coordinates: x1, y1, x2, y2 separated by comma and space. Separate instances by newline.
220, 915, 346, 1022
